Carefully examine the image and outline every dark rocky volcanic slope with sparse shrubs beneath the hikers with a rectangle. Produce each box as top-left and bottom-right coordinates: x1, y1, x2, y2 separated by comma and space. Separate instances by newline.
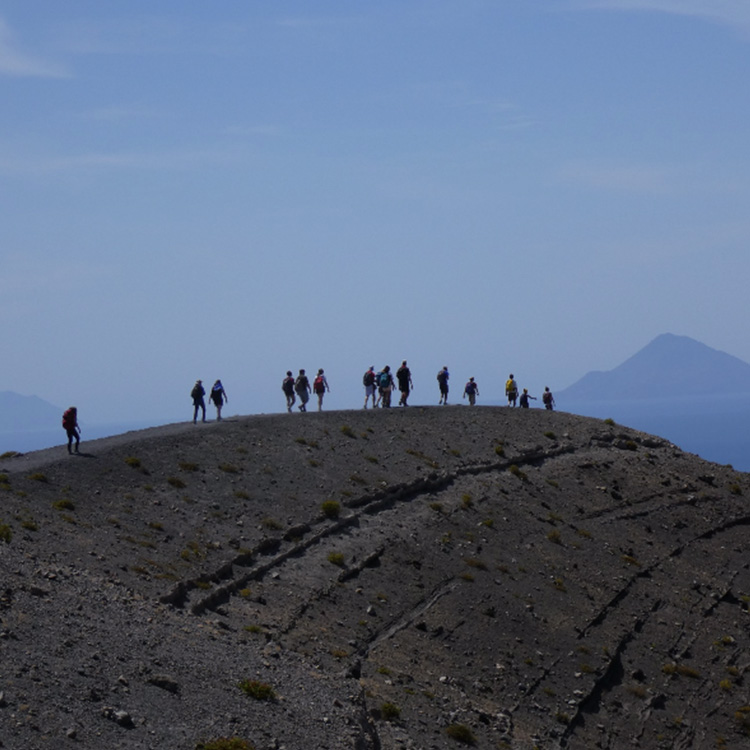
0, 407, 750, 750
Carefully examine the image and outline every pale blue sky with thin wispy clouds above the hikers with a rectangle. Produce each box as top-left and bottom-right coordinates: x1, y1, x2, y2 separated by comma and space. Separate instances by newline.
0, 0, 750, 422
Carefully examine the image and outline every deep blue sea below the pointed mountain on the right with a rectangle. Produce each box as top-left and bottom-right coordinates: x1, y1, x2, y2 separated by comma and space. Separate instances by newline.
557, 393, 750, 471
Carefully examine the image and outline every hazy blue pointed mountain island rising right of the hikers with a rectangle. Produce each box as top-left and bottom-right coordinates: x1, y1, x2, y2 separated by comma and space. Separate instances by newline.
557, 333, 750, 401
